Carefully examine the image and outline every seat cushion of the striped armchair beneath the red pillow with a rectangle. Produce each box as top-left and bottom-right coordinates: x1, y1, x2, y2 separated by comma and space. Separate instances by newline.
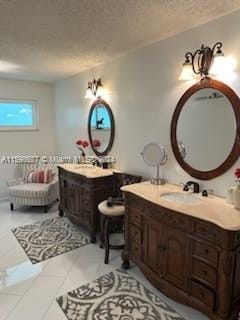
8, 183, 49, 198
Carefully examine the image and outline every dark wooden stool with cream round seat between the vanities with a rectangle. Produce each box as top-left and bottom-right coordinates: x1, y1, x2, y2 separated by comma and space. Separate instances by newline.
98, 200, 125, 264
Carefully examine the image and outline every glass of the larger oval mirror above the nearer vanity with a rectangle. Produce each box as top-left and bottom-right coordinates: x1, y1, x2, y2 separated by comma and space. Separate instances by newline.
176, 88, 236, 171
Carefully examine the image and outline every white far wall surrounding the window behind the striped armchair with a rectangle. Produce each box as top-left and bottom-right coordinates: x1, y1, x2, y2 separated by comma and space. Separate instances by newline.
0, 79, 55, 198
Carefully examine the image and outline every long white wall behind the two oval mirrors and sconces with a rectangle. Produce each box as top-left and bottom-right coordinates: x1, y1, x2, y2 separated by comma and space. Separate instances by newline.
55, 11, 240, 195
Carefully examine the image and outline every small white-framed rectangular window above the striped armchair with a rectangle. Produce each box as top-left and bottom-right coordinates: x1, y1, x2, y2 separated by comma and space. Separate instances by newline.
0, 99, 38, 130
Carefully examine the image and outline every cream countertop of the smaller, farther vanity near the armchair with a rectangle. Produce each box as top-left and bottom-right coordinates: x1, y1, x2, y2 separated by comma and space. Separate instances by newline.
58, 163, 117, 179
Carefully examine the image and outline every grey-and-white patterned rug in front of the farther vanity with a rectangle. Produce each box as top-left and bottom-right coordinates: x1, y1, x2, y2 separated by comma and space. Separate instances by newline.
12, 217, 90, 263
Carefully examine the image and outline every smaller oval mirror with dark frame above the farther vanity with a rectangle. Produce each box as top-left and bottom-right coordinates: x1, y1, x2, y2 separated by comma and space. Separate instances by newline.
88, 99, 114, 156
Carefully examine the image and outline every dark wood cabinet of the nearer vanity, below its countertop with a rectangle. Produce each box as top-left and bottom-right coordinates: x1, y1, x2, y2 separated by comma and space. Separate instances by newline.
122, 192, 240, 320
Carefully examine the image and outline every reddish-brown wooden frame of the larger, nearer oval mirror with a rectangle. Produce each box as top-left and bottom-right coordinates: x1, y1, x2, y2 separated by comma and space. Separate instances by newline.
171, 77, 240, 180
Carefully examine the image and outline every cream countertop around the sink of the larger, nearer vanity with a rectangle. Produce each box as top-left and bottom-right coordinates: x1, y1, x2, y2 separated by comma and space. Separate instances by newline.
121, 181, 240, 231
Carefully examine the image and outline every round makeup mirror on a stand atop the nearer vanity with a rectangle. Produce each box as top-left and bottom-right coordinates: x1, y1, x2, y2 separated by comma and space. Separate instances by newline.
141, 142, 167, 185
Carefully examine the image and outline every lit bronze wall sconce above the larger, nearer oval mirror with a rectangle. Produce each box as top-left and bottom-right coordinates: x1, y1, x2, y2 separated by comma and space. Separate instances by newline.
179, 42, 224, 80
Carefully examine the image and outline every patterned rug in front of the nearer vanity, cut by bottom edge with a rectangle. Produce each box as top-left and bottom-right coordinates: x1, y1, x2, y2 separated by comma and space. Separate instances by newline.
57, 270, 184, 320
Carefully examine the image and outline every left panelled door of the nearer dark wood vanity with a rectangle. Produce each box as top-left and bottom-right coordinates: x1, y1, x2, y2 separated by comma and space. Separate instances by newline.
143, 217, 162, 275
